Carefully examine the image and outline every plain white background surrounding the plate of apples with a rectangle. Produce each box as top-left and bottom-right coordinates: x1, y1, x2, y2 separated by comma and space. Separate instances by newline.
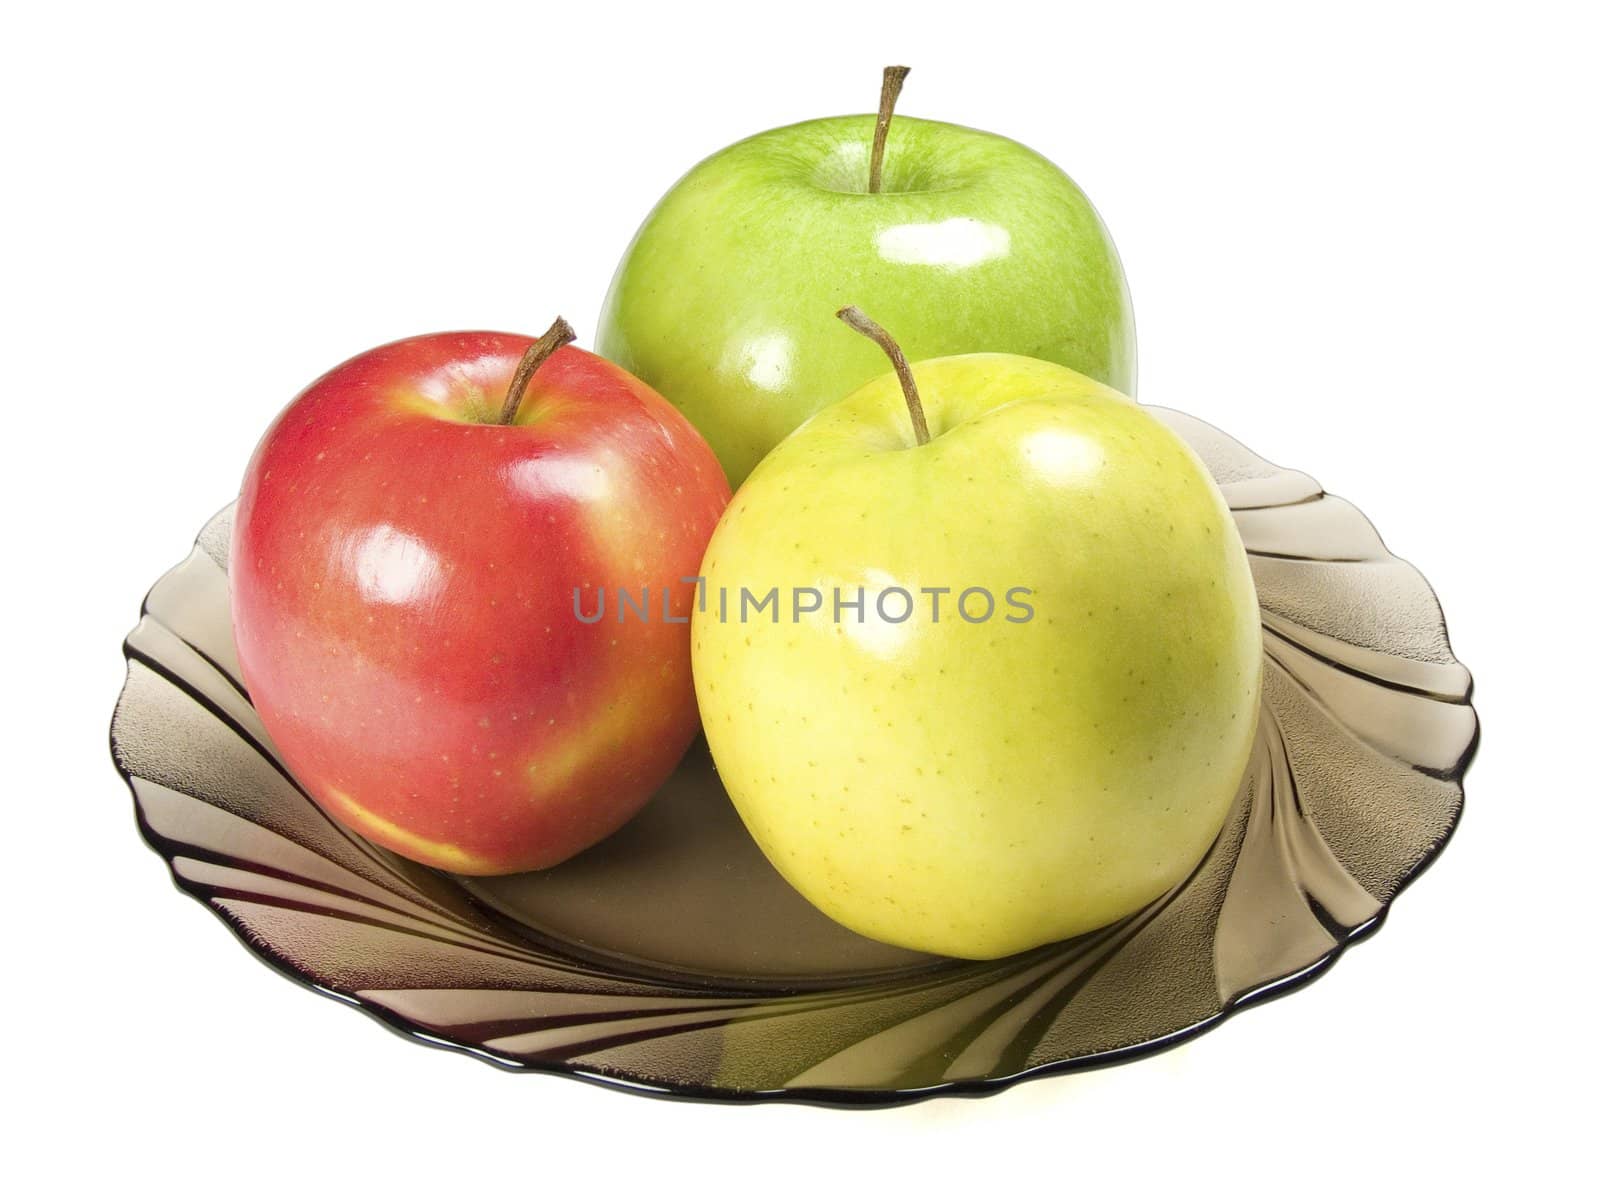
0, 0, 1600, 1195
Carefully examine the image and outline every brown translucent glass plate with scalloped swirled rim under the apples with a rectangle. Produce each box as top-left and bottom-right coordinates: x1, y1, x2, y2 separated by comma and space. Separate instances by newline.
112, 410, 1478, 1104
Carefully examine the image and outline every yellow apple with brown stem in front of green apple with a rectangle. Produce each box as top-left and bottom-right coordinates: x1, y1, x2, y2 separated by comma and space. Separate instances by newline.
691, 309, 1261, 958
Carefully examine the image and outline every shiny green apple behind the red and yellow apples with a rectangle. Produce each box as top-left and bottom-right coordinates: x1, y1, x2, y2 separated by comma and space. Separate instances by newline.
597, 117, 1136, 486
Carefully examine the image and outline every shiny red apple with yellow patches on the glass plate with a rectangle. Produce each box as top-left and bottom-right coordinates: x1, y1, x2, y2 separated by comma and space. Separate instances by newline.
229, 333, 728, 875
